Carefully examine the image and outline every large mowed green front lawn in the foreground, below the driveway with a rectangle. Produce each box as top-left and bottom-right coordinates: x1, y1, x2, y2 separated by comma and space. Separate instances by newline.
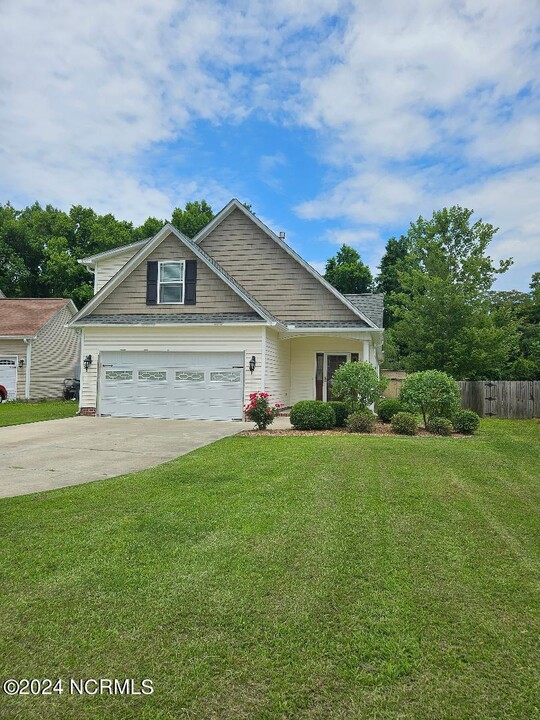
0, 421, 540, 720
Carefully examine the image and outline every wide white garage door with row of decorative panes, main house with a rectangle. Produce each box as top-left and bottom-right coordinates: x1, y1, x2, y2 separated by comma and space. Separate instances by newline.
98, 352, 244, 420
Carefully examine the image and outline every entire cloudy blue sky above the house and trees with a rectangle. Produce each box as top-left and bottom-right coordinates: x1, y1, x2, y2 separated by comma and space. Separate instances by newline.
0, 0, 540, 290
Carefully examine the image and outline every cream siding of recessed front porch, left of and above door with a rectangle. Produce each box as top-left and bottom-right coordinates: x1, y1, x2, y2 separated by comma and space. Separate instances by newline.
288, 335, 371, 405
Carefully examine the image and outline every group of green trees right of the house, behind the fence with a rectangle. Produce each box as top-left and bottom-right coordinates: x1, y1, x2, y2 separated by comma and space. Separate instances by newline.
325, 206, 540, 380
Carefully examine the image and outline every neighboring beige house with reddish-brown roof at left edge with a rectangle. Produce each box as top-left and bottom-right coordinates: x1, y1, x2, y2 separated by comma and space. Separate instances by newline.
0, 298, 80, 400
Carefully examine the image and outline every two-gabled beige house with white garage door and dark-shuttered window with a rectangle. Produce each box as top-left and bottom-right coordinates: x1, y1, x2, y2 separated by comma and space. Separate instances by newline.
70, 200, 383, 419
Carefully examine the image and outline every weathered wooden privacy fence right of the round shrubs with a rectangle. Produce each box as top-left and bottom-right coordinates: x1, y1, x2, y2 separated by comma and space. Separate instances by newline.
458, 380, 540, 420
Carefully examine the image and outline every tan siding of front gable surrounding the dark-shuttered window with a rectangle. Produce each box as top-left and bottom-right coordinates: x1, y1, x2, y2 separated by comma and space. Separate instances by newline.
94, 234, 253, 315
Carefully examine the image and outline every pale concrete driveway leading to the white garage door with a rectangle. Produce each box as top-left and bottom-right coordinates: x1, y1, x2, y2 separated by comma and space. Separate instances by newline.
0, 417, 246, 497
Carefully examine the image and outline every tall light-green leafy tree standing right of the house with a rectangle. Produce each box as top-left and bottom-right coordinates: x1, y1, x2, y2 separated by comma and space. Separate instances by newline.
392, 206, 518, 379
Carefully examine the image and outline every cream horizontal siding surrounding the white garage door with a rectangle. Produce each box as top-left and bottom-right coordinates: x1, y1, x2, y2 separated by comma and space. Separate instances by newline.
81, 326, 262, 412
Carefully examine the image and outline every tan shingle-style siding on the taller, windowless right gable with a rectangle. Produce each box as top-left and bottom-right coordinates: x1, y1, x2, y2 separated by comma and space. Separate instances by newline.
201, 210, 358, 320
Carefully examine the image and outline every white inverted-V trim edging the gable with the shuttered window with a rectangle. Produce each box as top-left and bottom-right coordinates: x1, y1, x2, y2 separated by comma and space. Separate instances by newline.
70, 223, 281, 327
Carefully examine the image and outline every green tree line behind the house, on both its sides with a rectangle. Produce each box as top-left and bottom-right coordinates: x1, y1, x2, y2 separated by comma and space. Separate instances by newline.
0, 200, 540, 380
